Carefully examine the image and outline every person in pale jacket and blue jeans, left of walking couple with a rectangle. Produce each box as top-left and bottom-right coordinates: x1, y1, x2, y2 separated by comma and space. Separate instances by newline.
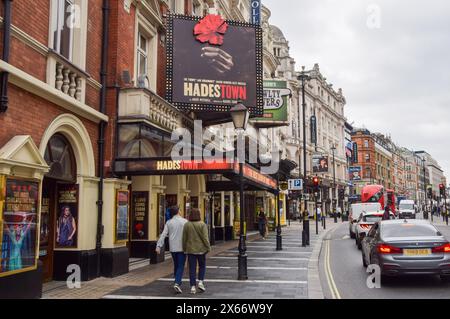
156, 206, 187, 294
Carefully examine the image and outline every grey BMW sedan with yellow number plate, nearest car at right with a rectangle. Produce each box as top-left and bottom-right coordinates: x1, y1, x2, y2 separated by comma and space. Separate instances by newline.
361, 219, 450, 281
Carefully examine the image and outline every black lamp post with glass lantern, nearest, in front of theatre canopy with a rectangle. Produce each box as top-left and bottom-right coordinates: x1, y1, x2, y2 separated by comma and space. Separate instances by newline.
230, 103, 250, 280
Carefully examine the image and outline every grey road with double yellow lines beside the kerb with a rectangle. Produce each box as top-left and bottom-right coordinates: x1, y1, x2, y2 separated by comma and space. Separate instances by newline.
320, 215, 450, 299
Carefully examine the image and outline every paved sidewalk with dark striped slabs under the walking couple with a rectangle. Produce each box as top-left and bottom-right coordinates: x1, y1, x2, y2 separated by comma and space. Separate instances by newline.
43, 219, 341, 299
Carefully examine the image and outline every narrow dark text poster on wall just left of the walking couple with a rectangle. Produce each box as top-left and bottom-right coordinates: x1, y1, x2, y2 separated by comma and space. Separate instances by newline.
131, 192, 149, 240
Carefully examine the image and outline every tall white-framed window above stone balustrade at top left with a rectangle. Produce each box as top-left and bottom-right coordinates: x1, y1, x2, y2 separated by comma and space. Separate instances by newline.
52, 0, 75, 61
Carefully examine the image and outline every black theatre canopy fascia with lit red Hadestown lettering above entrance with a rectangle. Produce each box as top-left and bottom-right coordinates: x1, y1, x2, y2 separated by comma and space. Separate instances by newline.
114, 158, 278, 192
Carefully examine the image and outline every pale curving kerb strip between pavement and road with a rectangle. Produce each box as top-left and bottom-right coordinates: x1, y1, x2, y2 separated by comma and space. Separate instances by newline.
308, 224, 339, 299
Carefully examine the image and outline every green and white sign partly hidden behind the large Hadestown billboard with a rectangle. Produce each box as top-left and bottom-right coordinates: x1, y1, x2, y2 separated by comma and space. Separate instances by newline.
254, 81, 291, 127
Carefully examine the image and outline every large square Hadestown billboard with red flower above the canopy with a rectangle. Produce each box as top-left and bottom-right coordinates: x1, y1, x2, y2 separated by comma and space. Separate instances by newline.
166, 14, 263, 116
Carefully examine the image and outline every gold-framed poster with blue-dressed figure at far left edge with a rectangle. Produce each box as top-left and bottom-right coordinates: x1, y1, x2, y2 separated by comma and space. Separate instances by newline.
0, 177, 39, 277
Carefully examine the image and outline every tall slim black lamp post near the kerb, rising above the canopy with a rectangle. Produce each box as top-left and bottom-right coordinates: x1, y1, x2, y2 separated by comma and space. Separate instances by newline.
298, 66, 310, 247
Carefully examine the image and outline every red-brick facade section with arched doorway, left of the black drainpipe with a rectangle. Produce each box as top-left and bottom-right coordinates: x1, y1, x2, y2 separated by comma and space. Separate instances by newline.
0, 0, 109, 298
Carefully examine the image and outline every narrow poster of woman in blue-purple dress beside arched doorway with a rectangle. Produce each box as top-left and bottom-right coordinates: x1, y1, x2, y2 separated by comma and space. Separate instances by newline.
55, 184, 79, 248
